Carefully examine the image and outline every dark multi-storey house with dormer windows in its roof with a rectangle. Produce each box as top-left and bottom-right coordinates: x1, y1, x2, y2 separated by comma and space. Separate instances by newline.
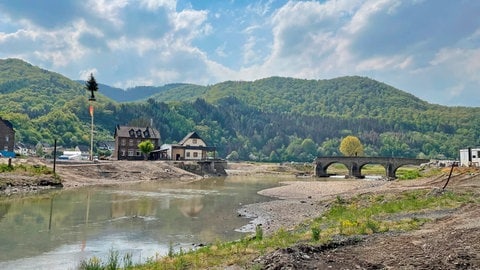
113, 125, 160, 160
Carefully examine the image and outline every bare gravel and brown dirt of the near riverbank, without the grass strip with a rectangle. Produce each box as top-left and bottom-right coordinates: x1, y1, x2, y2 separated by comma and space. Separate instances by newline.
238, 170, 480, 269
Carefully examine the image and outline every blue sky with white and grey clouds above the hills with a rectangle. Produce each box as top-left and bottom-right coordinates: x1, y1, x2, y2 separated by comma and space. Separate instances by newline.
0, 0, 480, 107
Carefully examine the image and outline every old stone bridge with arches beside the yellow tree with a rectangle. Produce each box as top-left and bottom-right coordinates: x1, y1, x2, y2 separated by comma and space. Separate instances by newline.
314, 157, 430, 178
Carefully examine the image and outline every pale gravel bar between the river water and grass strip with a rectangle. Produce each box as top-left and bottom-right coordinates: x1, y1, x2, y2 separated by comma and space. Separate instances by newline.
238, 175, 480, 234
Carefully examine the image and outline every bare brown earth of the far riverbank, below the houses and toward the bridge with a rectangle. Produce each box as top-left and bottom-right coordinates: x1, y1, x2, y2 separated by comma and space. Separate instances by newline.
0, 157, 308, 196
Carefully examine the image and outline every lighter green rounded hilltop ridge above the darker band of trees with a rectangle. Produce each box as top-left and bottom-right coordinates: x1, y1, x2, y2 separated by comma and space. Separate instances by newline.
148, 76, 435, 118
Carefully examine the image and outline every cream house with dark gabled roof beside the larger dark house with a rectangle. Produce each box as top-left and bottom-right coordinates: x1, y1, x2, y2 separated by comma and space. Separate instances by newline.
155, 132, 216, 160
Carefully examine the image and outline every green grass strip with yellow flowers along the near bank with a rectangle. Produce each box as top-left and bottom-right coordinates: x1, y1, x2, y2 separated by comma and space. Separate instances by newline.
79, 190, 480, 269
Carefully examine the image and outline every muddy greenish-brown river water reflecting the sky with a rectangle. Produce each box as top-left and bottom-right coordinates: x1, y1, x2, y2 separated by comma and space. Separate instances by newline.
0, 176, 293, 270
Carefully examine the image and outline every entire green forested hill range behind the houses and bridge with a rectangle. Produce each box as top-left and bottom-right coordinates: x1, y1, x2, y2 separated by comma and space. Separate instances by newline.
0, 59, 480, 161
